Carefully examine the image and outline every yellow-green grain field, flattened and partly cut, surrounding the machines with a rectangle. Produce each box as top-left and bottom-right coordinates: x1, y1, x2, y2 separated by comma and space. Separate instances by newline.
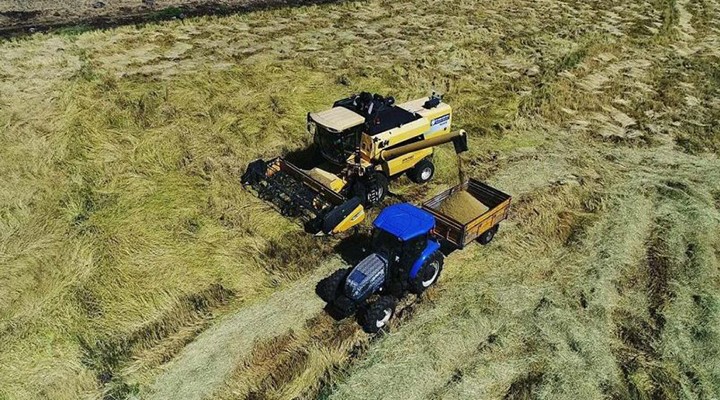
0, 0, 720, 400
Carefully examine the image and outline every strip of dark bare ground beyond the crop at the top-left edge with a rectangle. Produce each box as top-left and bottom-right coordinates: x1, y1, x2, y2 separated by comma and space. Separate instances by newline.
0, 0, 333, 37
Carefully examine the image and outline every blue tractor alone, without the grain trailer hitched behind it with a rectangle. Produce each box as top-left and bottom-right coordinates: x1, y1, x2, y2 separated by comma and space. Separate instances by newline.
316, 203, 444, 333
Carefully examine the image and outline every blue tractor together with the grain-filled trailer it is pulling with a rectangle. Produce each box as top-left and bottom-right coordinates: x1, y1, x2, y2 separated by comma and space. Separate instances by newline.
316, 178, 512, 333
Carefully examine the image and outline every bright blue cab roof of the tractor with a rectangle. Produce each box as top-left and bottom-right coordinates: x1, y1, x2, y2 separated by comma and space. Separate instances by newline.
373, 203, 435, 241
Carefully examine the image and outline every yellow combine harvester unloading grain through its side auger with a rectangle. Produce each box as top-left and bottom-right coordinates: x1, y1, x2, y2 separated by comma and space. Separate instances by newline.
242, 92, 467, 234
